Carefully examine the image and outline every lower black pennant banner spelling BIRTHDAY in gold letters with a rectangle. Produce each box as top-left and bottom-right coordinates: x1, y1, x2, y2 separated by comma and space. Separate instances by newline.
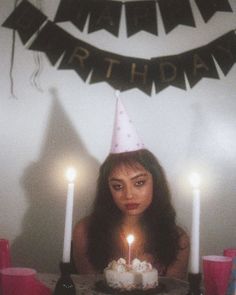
3, 0, 236, 95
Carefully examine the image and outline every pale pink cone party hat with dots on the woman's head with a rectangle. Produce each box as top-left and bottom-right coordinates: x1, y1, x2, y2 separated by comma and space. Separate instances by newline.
110, 91, 144, 154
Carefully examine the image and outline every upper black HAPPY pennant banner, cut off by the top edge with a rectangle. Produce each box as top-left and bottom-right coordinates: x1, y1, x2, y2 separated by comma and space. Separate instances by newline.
49, 0, 232, 37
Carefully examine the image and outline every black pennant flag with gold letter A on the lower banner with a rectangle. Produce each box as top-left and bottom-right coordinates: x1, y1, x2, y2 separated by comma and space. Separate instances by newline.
180, 46, 219, 88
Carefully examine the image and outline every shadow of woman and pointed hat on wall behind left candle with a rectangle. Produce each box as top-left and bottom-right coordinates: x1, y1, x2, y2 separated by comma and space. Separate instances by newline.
11, 90, 99, 272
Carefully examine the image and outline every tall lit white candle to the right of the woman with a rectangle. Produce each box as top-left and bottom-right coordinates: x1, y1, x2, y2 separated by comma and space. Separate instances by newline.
190, 173, 200, 273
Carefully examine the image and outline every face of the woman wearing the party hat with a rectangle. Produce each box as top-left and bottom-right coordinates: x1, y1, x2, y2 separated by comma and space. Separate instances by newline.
108, 164, 153, 219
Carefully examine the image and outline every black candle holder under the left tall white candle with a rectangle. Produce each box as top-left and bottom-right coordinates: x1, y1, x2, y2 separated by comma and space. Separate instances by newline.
53, 262, 76, 295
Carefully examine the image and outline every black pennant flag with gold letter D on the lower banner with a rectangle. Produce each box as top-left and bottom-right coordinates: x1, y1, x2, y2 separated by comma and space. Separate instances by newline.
151, 55, 186, 93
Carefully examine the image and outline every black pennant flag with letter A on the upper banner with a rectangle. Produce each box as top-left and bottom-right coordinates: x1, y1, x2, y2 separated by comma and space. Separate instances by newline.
88, 1, 122, 36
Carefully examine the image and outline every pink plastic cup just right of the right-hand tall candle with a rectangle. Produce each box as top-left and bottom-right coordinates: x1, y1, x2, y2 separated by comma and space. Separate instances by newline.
203, 255, 232, 295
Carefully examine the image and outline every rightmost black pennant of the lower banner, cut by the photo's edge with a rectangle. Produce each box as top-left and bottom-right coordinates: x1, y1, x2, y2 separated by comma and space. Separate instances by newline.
209, 31, 236, 75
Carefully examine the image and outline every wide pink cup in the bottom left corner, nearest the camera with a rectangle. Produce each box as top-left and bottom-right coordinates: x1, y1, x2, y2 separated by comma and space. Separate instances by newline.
0, 267, 37, 295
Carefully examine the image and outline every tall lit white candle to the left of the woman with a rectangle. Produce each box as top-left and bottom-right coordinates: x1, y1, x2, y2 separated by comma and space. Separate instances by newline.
62, 167, 76, 263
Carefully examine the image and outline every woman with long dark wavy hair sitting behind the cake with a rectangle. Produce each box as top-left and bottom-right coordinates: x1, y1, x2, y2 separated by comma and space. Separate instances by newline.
73, 149, 189, 279
